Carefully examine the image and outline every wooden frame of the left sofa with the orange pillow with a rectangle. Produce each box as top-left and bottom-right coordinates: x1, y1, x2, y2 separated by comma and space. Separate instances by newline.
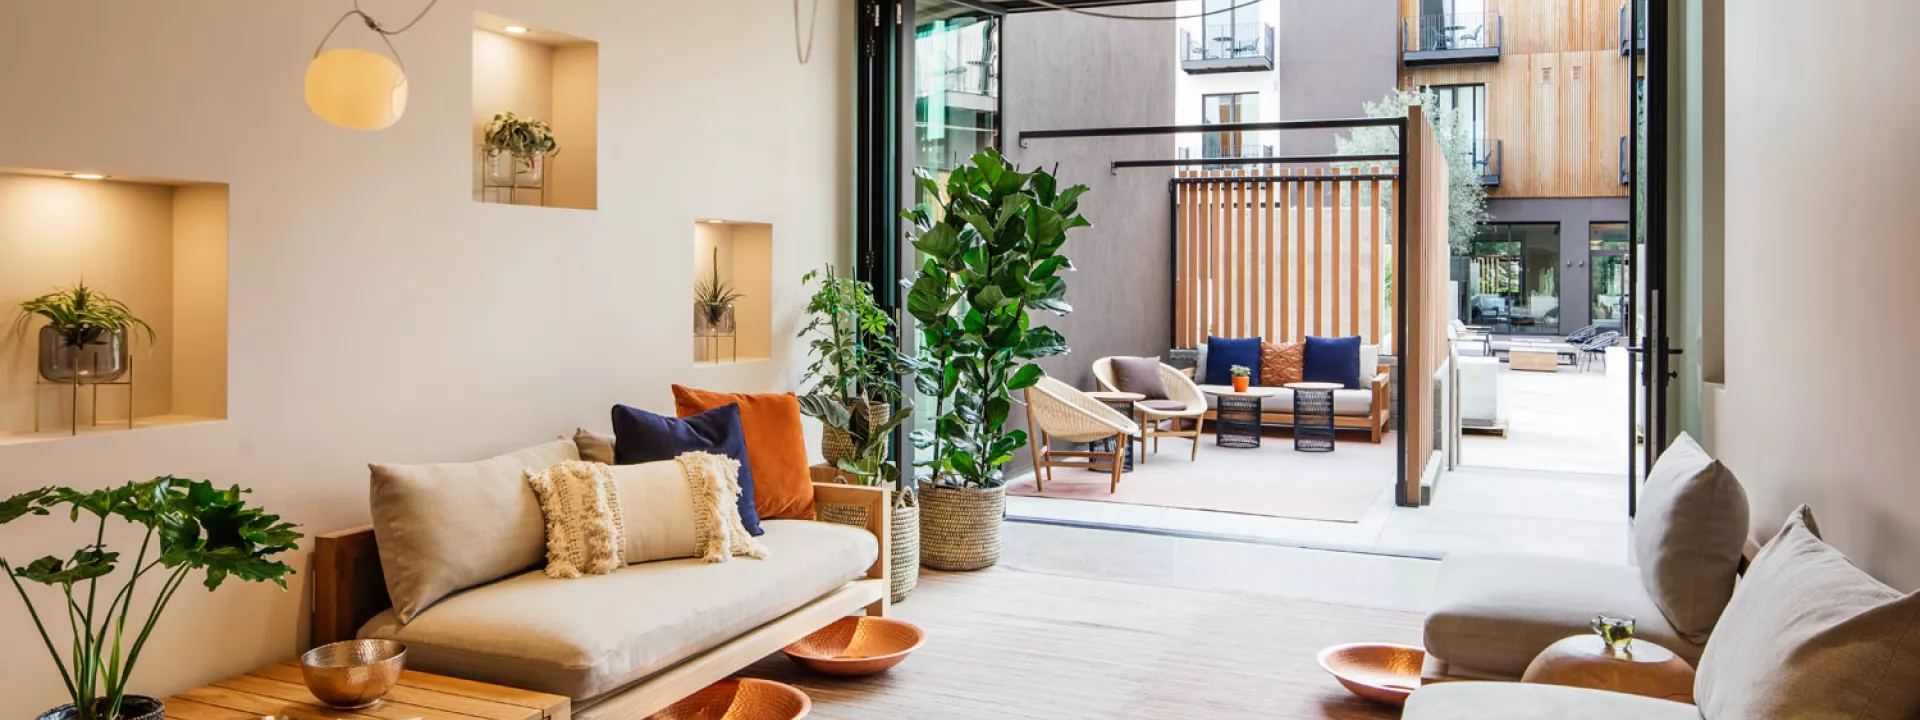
313, 482, 893, 720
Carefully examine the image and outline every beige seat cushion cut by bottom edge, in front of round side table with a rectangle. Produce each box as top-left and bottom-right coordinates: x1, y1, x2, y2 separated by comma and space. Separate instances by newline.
1402, 682, 1701, 720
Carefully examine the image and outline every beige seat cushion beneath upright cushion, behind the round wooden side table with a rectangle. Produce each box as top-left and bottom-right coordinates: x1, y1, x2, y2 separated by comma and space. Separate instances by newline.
1427, 553, 1699, 678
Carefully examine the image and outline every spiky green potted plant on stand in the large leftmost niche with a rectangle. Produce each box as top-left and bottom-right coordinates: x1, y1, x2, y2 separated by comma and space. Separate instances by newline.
13, 280, 154, 384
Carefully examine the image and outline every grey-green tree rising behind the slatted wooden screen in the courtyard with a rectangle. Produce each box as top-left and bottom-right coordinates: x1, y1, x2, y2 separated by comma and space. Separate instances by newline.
1334, 90, 1488, 255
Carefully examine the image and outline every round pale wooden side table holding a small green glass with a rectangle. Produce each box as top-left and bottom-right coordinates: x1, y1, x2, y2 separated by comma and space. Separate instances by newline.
1521, 636, 1693, 705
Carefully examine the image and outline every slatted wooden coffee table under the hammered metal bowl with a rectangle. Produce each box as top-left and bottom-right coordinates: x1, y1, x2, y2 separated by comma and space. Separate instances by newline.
165, 660, 572, 720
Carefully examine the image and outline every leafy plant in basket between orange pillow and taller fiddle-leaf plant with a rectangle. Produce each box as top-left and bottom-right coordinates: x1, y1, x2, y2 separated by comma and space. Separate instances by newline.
799, 265, 920, 603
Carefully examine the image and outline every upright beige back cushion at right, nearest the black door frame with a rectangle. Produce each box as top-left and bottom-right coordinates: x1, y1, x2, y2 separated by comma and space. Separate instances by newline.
1632, 432, 1747, 643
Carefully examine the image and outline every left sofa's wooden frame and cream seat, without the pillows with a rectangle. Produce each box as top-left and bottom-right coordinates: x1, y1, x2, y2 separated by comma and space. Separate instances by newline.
313, 449, 889, 718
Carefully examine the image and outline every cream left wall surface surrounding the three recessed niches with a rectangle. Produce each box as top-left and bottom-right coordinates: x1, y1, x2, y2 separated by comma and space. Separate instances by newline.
0, 0, 852, 718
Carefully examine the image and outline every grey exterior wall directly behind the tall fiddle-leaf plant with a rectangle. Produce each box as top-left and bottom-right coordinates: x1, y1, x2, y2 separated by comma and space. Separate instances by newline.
1002, 6, 1175, 474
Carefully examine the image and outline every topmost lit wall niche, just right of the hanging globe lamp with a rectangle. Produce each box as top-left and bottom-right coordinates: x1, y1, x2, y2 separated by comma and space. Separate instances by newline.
472, 12, 599, 209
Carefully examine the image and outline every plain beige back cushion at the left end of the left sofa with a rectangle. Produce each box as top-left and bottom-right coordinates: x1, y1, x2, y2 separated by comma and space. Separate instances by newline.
369, 440, 580, 622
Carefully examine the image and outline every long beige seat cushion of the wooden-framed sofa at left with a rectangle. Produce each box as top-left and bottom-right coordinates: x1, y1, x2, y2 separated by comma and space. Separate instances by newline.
359, 520, 879, 701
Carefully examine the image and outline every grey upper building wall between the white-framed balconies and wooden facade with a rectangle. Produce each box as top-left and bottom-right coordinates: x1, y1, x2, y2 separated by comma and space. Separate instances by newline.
1275, 0, 1400, 156
